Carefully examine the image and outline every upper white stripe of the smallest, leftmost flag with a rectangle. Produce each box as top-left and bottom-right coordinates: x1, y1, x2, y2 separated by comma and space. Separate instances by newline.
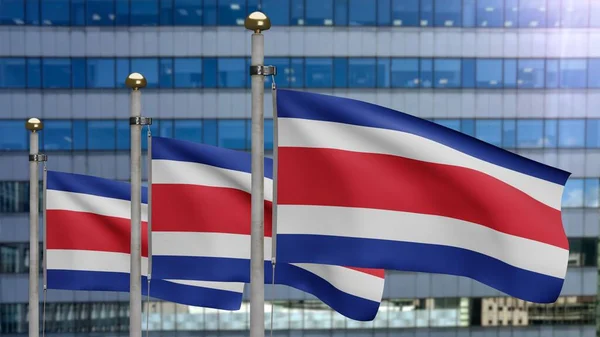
46, 190, 148, 221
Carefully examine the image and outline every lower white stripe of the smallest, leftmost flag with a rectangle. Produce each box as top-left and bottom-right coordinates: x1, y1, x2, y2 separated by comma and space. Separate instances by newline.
46, 249, 244, 293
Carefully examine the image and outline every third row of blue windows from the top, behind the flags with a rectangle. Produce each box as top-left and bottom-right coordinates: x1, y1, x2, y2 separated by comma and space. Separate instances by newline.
0, 118, 600, 151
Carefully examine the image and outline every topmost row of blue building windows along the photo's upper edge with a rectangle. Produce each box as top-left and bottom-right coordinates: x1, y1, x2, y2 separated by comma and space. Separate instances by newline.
0, 0, 600, 28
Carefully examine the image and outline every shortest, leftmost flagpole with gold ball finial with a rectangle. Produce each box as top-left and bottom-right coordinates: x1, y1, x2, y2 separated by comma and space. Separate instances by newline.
25, 118, 46, 337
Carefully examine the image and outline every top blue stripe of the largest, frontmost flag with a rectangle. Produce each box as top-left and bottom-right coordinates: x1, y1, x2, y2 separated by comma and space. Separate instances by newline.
277, 89, 570, 185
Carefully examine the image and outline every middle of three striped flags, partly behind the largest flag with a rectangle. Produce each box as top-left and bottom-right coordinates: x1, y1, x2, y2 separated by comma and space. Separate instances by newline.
152, 137, 384, 321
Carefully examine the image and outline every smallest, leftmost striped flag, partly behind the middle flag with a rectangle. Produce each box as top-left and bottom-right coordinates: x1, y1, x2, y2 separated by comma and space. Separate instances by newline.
46, 171, 244, 310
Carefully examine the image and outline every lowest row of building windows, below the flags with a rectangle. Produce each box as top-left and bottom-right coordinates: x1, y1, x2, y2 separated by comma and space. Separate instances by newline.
0, 296, 596, 333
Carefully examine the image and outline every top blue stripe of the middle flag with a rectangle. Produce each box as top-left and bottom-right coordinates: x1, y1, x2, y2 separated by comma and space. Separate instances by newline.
152, 137, 273, 179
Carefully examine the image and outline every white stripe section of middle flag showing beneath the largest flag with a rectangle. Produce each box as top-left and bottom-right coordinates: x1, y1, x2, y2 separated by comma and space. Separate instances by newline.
292, 263, 385, 302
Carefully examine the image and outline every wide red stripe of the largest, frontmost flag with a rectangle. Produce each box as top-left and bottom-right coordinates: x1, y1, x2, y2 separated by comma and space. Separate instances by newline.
278, 147, 569, 249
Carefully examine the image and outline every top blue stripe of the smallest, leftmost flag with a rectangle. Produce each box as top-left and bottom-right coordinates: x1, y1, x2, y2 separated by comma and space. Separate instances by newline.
48, 171, 148, 204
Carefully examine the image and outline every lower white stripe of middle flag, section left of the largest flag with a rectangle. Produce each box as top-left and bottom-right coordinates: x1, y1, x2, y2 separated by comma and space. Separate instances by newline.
152, 232, 271, 261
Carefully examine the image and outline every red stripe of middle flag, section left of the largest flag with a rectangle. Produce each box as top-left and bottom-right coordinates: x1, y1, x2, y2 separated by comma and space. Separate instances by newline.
152, 184, 272, 237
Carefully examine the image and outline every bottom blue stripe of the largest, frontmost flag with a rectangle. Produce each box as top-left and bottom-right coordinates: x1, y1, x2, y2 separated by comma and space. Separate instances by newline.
277, 234, 564, 303
